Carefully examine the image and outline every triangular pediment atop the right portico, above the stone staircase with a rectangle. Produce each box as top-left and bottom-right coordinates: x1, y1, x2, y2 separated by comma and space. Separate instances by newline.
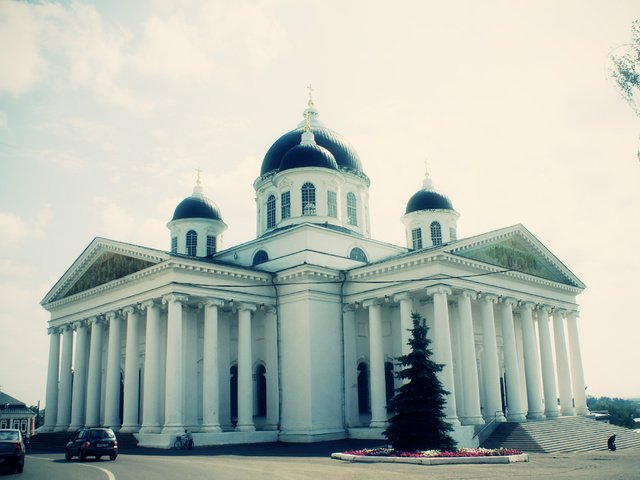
446, 225, 585, 288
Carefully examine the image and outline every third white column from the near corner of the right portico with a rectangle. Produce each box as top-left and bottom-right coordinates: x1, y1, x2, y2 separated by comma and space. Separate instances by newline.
480, 295, 506, 422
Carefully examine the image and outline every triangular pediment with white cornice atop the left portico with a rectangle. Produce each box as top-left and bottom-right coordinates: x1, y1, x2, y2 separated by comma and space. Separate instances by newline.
42, 238, 169, 305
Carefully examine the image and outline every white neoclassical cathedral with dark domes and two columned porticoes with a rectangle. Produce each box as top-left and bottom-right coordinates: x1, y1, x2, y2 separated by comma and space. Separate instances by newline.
42, 100, 589, 447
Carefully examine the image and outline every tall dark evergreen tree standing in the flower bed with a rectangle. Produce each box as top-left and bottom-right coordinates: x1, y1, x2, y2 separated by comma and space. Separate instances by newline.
384, 313, 456, 452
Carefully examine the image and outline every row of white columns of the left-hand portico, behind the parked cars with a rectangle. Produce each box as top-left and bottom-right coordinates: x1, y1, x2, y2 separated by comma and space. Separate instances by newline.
44, 293, 277, 434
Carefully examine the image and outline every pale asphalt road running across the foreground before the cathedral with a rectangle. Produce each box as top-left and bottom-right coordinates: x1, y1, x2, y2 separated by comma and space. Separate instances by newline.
12, 444, 640, 480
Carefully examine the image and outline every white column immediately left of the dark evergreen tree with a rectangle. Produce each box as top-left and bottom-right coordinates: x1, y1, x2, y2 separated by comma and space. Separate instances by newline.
363, 300, 387, 428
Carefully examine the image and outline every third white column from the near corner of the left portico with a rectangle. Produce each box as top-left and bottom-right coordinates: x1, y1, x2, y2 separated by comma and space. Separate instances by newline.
120, 306, 140, 433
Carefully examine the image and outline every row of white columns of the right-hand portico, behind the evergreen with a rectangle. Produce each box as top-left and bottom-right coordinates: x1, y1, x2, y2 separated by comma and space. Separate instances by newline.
352, 285, 588, 428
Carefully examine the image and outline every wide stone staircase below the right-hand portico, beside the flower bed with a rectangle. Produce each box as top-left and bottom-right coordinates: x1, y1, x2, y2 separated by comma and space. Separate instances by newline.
482, 417, 640, 453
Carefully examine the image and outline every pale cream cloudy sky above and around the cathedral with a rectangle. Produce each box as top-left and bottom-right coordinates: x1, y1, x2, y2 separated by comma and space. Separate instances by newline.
0, 0, 640, 405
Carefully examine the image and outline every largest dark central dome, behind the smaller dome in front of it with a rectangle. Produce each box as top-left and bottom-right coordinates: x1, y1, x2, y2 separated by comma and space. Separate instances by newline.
260, 125, 363, 175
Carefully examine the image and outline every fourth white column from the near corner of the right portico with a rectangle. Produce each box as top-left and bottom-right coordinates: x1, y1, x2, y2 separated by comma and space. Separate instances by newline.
500, 298, 526, 422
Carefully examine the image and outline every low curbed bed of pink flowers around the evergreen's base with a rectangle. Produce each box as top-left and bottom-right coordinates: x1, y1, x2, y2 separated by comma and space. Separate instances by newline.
331, 447, 529, 465
